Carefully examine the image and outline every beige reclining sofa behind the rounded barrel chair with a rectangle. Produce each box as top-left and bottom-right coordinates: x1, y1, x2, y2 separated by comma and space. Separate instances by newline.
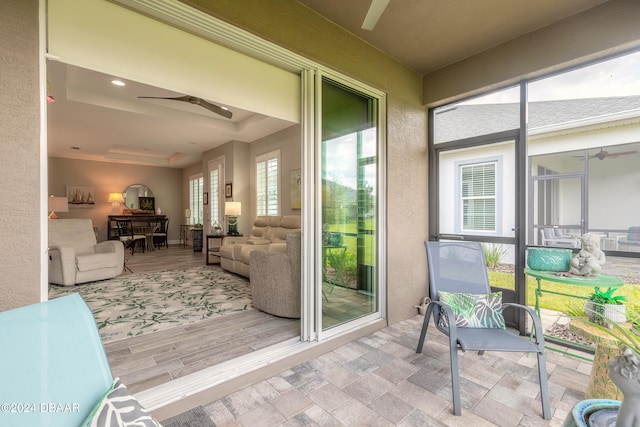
220, 215, 300, 277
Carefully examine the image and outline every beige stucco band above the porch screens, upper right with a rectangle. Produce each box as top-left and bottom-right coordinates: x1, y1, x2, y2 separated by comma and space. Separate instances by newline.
422, 0, 640, 106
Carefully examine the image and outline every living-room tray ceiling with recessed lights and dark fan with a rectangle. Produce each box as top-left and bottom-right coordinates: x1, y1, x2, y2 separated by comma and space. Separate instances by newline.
47, 61, 293, 168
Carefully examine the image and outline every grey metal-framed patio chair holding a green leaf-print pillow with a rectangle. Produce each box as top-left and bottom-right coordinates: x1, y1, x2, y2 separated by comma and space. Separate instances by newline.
416, 242, 551, 419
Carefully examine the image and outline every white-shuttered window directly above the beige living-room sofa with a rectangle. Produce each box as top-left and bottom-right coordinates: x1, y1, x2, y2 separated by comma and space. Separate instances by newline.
256, 150, 280, 216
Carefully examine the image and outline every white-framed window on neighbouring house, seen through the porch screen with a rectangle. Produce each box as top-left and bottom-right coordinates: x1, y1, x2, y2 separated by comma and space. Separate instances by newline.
460, 162, 496, 231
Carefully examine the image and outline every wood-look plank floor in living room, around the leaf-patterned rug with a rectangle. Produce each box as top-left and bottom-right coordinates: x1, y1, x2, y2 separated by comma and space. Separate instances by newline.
104, 245, 300, 393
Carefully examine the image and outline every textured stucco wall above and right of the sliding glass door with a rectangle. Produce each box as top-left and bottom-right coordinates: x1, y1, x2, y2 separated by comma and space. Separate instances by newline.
183, 0, 428, 323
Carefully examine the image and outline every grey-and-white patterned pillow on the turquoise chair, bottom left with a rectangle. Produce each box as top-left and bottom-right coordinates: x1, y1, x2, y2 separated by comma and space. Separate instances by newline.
80, 378, 162, 427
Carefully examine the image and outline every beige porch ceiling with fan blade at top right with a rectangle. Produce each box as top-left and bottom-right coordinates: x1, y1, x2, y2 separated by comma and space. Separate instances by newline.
298, 0, 607, 75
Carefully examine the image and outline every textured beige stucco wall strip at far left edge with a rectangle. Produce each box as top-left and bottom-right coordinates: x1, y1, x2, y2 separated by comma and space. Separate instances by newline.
0, 0, 41, 311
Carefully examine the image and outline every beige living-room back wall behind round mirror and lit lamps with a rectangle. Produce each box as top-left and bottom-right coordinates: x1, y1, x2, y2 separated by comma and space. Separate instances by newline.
48, 157, 182, 243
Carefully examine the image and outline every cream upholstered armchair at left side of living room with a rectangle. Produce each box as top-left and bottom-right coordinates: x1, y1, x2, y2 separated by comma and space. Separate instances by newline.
49, 219, 124, 286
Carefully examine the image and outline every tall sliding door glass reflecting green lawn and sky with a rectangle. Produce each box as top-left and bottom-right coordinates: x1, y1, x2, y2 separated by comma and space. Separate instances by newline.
321, 79, 379, 330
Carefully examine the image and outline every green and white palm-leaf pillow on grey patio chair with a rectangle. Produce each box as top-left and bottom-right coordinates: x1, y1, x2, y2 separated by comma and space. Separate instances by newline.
438, 292, 506, 329
